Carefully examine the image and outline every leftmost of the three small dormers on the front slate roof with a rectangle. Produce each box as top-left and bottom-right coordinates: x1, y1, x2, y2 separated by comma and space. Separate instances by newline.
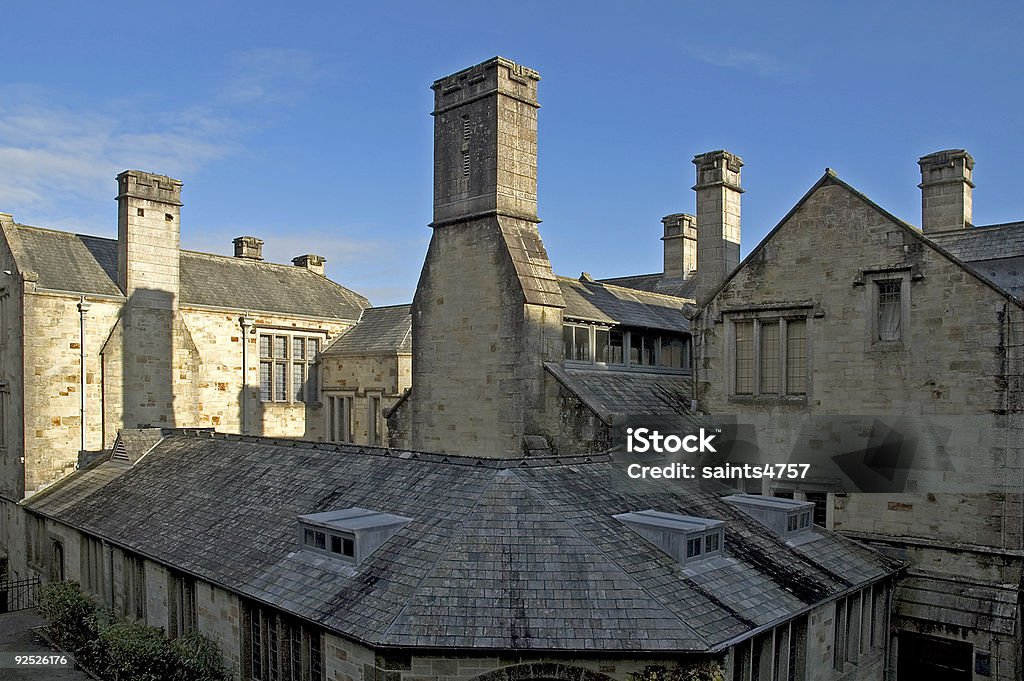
299, 506, 413, 565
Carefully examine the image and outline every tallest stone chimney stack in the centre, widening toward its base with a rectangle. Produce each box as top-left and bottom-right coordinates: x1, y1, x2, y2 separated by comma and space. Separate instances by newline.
402, 57, 564, 458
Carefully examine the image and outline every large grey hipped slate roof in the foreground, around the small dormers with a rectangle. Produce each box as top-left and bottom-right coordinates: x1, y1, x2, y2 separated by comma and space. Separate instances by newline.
26, 430, 897, 651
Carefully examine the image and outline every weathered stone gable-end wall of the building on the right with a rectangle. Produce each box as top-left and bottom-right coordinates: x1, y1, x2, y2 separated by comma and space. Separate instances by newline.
694, 177, 1024, 681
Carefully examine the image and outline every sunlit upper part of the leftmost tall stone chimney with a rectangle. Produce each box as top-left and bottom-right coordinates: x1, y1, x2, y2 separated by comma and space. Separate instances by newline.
117, 170, 181, 309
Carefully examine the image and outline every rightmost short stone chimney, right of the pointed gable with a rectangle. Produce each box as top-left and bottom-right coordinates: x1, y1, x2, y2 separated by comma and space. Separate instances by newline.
918, 148, 974, 233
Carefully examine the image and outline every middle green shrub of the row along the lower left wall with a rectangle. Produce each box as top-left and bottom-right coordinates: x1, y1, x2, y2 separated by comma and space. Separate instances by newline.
96, 622, 172, 681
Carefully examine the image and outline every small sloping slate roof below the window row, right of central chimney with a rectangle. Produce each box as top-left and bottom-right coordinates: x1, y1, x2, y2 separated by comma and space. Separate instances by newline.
545, 361, 708, 432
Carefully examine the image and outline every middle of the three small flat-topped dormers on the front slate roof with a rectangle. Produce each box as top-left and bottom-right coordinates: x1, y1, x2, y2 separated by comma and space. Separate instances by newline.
612, 509, 725, 565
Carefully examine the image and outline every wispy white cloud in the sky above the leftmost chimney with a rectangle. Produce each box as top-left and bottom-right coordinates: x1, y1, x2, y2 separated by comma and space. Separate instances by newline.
0, 49, 319, 227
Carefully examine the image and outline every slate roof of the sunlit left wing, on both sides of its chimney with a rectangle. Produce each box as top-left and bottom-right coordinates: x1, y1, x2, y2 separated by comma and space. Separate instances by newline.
11, 224, 370, 320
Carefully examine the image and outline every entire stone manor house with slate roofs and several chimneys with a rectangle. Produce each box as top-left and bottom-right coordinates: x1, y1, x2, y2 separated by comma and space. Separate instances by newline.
0, 57, 1024, 681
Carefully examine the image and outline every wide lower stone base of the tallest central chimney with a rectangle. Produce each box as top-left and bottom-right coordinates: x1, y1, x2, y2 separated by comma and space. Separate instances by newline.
401, 217, 562, 457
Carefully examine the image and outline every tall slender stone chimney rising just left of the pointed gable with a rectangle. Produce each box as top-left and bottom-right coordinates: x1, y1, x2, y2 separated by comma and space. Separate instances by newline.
693, 151, 743, 305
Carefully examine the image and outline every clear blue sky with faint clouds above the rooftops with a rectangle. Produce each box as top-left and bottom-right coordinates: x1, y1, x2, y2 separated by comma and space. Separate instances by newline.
0, 1, 1024, 304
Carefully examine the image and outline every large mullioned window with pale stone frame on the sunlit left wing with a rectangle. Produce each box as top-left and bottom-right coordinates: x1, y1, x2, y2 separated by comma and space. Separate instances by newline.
256, 327, 327, 407
